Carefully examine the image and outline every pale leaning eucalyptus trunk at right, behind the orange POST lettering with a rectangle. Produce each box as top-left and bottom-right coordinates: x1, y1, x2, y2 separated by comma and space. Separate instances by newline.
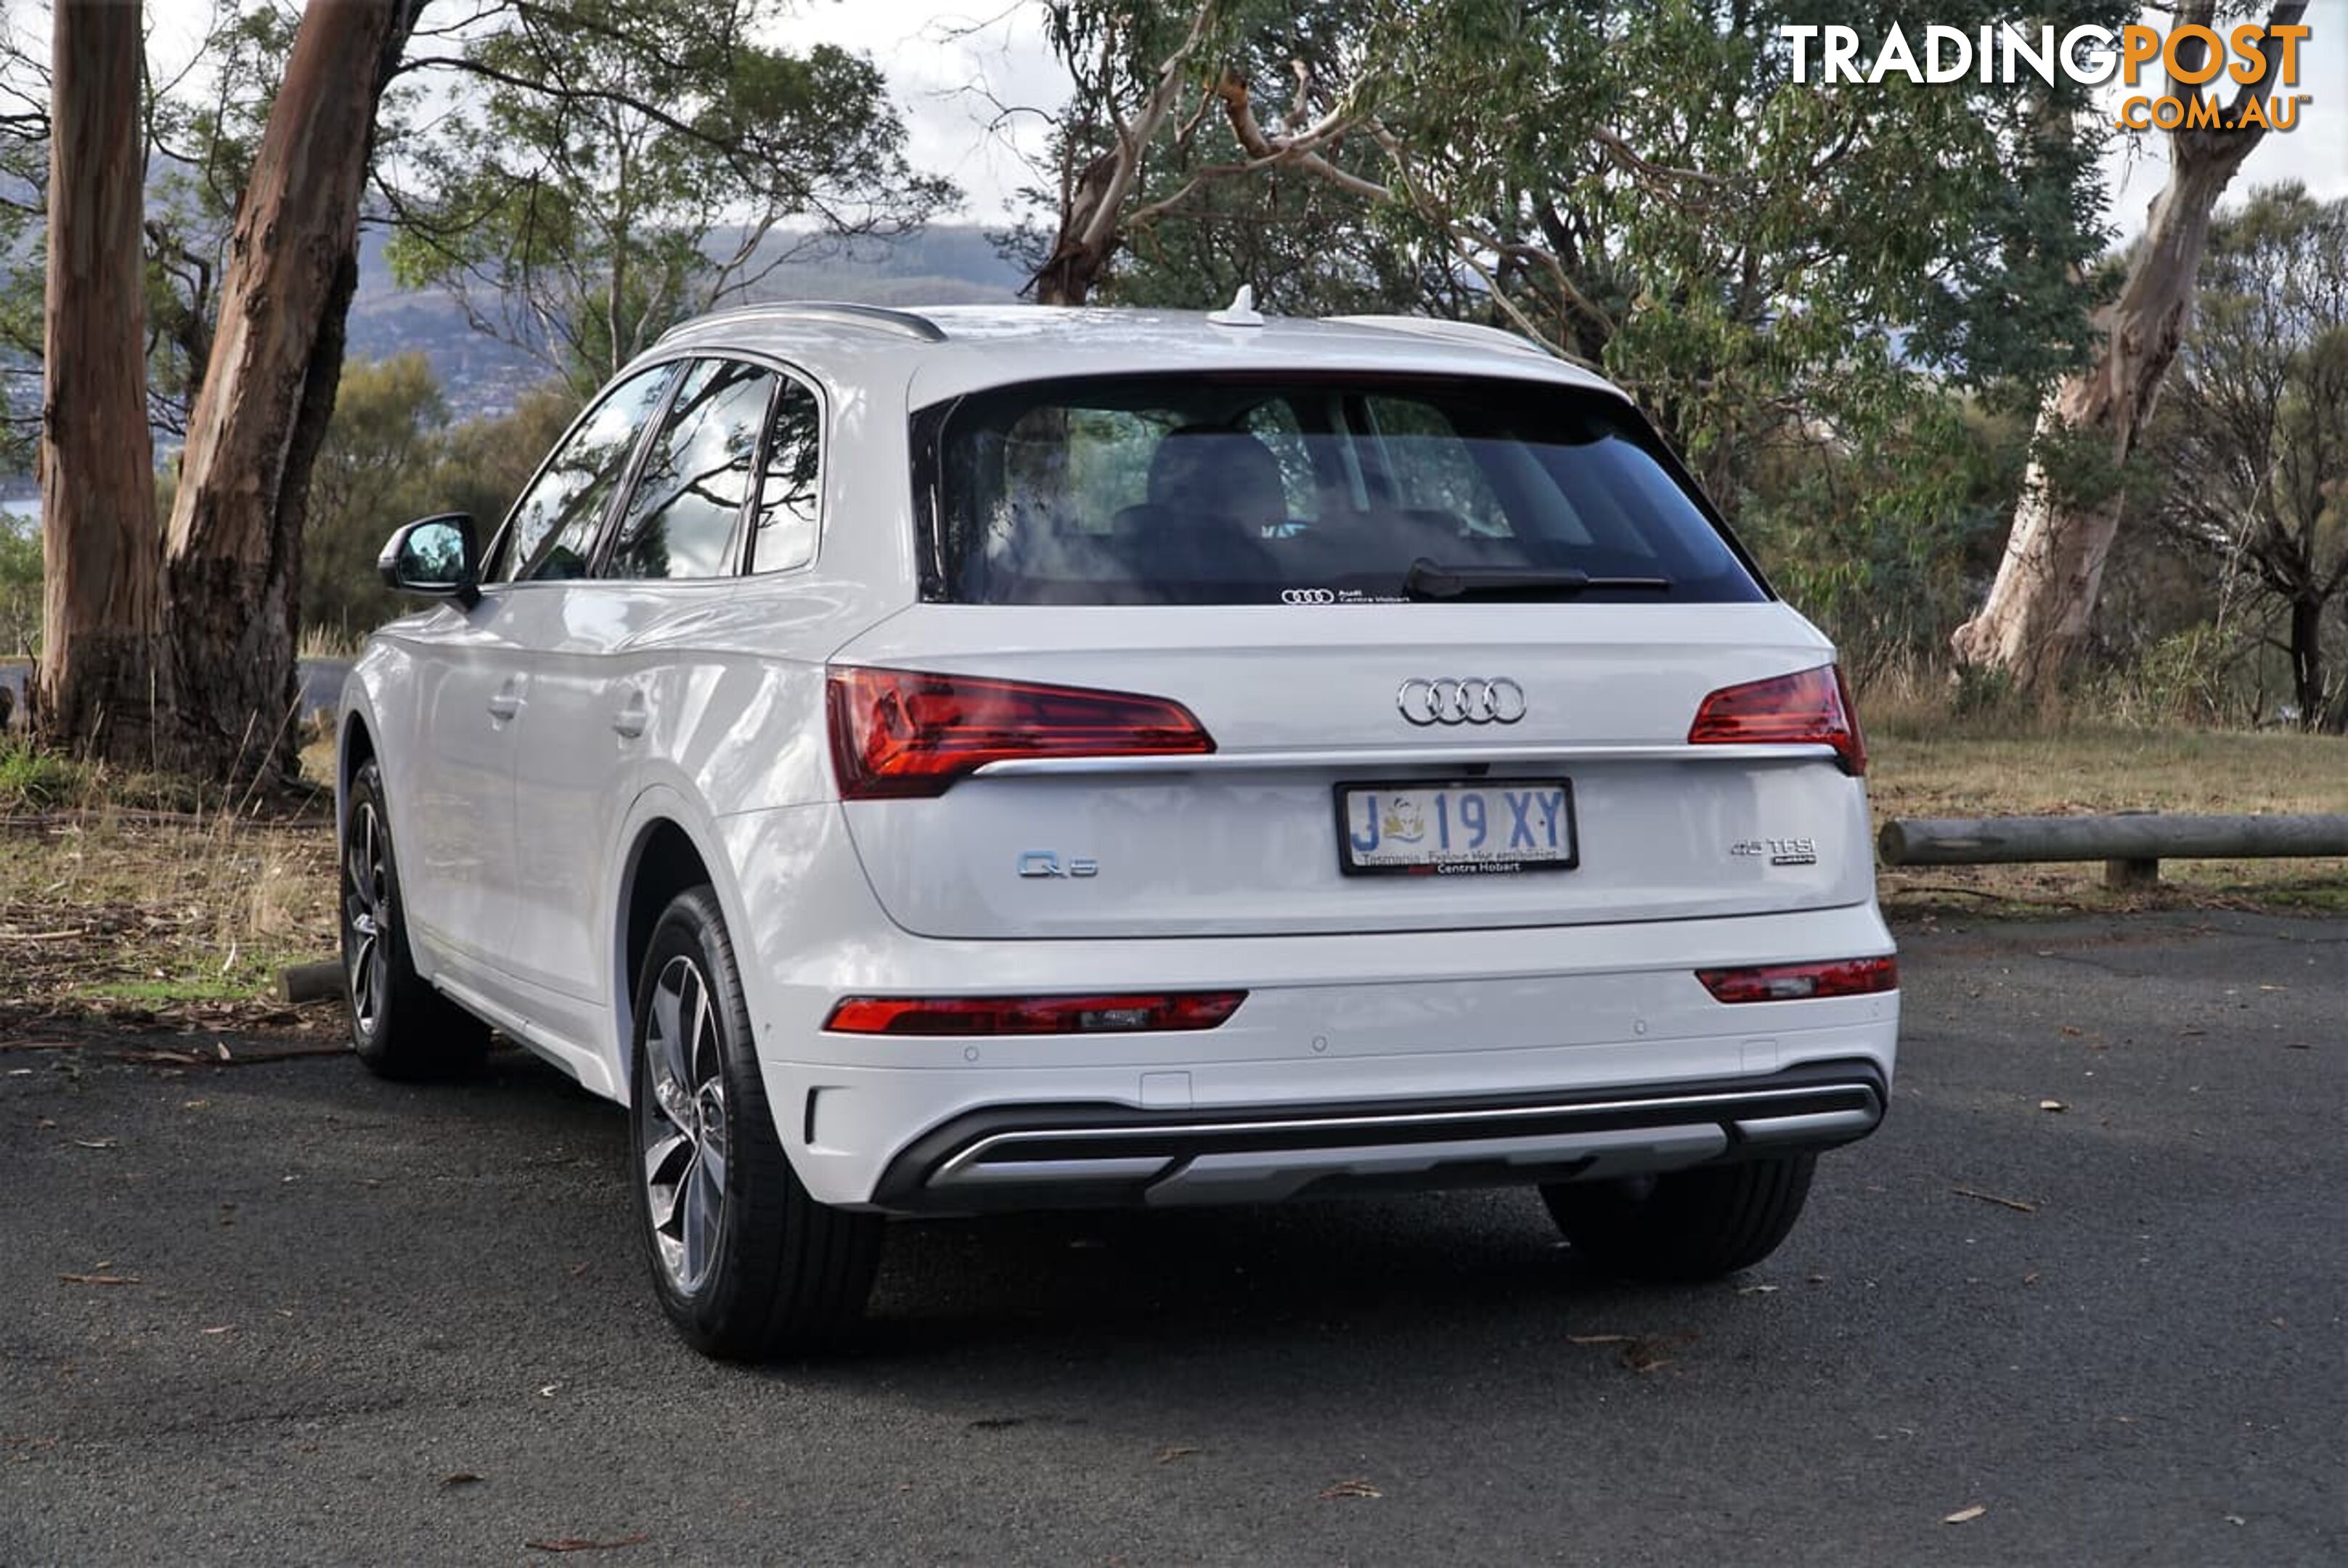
1949, 0, 2306, 695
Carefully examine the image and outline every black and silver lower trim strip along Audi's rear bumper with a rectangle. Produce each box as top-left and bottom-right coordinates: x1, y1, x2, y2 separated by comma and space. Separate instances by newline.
871, 1058, 1886, 1214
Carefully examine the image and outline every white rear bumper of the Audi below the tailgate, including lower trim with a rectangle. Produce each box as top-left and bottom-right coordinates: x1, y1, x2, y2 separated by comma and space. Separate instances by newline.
704, 807, 1899, 1212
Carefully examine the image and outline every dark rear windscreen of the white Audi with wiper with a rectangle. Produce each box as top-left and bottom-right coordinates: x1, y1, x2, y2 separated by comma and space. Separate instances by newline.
916, 373, 1768, 603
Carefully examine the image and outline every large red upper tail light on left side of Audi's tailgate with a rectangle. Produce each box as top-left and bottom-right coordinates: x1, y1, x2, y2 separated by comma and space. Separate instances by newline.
826, 664, 1214, 801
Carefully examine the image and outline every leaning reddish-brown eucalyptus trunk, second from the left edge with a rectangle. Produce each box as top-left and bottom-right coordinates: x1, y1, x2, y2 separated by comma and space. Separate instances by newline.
164, 0, 418, 780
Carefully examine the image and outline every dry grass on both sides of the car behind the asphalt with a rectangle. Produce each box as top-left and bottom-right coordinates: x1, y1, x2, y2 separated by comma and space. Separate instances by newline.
0, 709, 2348, 1040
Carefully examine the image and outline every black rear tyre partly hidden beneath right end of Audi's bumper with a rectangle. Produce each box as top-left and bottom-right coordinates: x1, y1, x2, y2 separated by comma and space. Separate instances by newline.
1541, 1155, 1817, 1284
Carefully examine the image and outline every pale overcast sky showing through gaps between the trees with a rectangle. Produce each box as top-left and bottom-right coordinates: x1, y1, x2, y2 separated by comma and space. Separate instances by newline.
148, 0, 2348, 237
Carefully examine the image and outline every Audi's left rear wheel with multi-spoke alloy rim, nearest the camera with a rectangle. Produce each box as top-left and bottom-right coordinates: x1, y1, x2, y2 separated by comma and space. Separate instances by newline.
627, 887, 883, 1361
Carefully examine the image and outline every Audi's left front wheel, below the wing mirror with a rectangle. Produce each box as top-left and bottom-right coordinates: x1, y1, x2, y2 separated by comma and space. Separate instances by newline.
338, 758, 489, 1082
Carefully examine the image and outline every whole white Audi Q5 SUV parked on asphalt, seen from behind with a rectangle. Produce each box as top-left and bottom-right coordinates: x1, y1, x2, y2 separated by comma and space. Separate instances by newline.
338, 303, 1899, 1357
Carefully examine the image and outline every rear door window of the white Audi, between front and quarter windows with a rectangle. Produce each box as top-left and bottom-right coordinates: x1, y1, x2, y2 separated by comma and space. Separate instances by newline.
603, 359, 775, 580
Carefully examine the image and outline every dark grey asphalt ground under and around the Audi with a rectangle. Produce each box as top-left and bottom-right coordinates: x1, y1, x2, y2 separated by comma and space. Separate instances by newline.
0, 915, 2348, 1566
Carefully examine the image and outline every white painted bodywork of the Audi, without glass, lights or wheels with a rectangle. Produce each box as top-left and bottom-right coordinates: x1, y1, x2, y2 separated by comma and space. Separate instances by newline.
343, 308, 1899, 1206
